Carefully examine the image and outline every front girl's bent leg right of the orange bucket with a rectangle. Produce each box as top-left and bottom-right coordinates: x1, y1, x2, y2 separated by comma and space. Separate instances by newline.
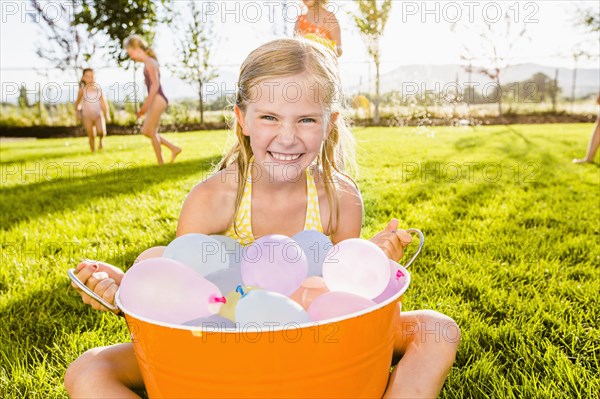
383, 310, 460, 398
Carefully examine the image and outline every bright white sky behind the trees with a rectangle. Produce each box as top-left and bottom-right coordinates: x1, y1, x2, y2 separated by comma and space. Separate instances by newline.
0, 0, 600, 100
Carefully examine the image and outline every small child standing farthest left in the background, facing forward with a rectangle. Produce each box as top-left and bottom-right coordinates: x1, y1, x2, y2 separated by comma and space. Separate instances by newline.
75, 68, 110, 152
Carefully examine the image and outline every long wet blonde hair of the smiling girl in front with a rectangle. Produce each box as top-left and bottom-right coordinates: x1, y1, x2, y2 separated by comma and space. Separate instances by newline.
215, 38, 356, 235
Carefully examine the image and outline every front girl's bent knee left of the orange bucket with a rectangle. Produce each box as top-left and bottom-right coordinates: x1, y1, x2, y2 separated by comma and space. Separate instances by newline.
65, 343, 144, 398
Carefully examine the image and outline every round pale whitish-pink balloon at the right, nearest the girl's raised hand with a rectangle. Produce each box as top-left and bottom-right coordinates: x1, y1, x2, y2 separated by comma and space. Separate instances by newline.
323, 238, 390, 299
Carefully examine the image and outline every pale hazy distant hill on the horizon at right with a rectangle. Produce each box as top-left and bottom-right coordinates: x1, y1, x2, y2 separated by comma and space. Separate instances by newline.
366, 64, 600, 97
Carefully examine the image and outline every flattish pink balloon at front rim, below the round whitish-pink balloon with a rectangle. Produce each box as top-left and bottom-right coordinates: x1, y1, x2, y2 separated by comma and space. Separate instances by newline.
308, 292, 377, 321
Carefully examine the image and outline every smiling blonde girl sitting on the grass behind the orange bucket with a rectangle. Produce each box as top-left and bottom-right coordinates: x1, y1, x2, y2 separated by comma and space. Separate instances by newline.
65, 39, 459, 398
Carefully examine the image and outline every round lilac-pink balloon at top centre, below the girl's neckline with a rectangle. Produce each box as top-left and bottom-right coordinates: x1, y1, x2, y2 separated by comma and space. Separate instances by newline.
241, 234, 308, 296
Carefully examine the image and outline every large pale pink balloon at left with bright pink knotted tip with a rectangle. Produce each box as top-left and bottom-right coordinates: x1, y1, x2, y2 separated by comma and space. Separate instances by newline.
119, 258, 225, 324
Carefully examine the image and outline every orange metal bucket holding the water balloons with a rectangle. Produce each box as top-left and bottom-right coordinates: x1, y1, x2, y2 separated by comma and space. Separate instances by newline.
117, 265, 410, 398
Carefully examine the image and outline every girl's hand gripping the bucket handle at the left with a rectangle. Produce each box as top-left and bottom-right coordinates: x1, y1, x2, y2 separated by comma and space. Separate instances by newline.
71, 261, 125, 313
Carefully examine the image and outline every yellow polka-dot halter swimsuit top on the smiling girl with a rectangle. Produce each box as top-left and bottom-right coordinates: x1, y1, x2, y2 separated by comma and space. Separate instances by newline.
225, 159, 323, 245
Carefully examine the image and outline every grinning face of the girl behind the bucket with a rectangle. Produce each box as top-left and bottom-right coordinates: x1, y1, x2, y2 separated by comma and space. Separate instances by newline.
235, 73, 337, 181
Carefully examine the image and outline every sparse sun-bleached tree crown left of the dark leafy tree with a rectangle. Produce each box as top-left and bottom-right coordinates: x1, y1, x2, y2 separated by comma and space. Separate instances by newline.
30, 0, 97, 81
